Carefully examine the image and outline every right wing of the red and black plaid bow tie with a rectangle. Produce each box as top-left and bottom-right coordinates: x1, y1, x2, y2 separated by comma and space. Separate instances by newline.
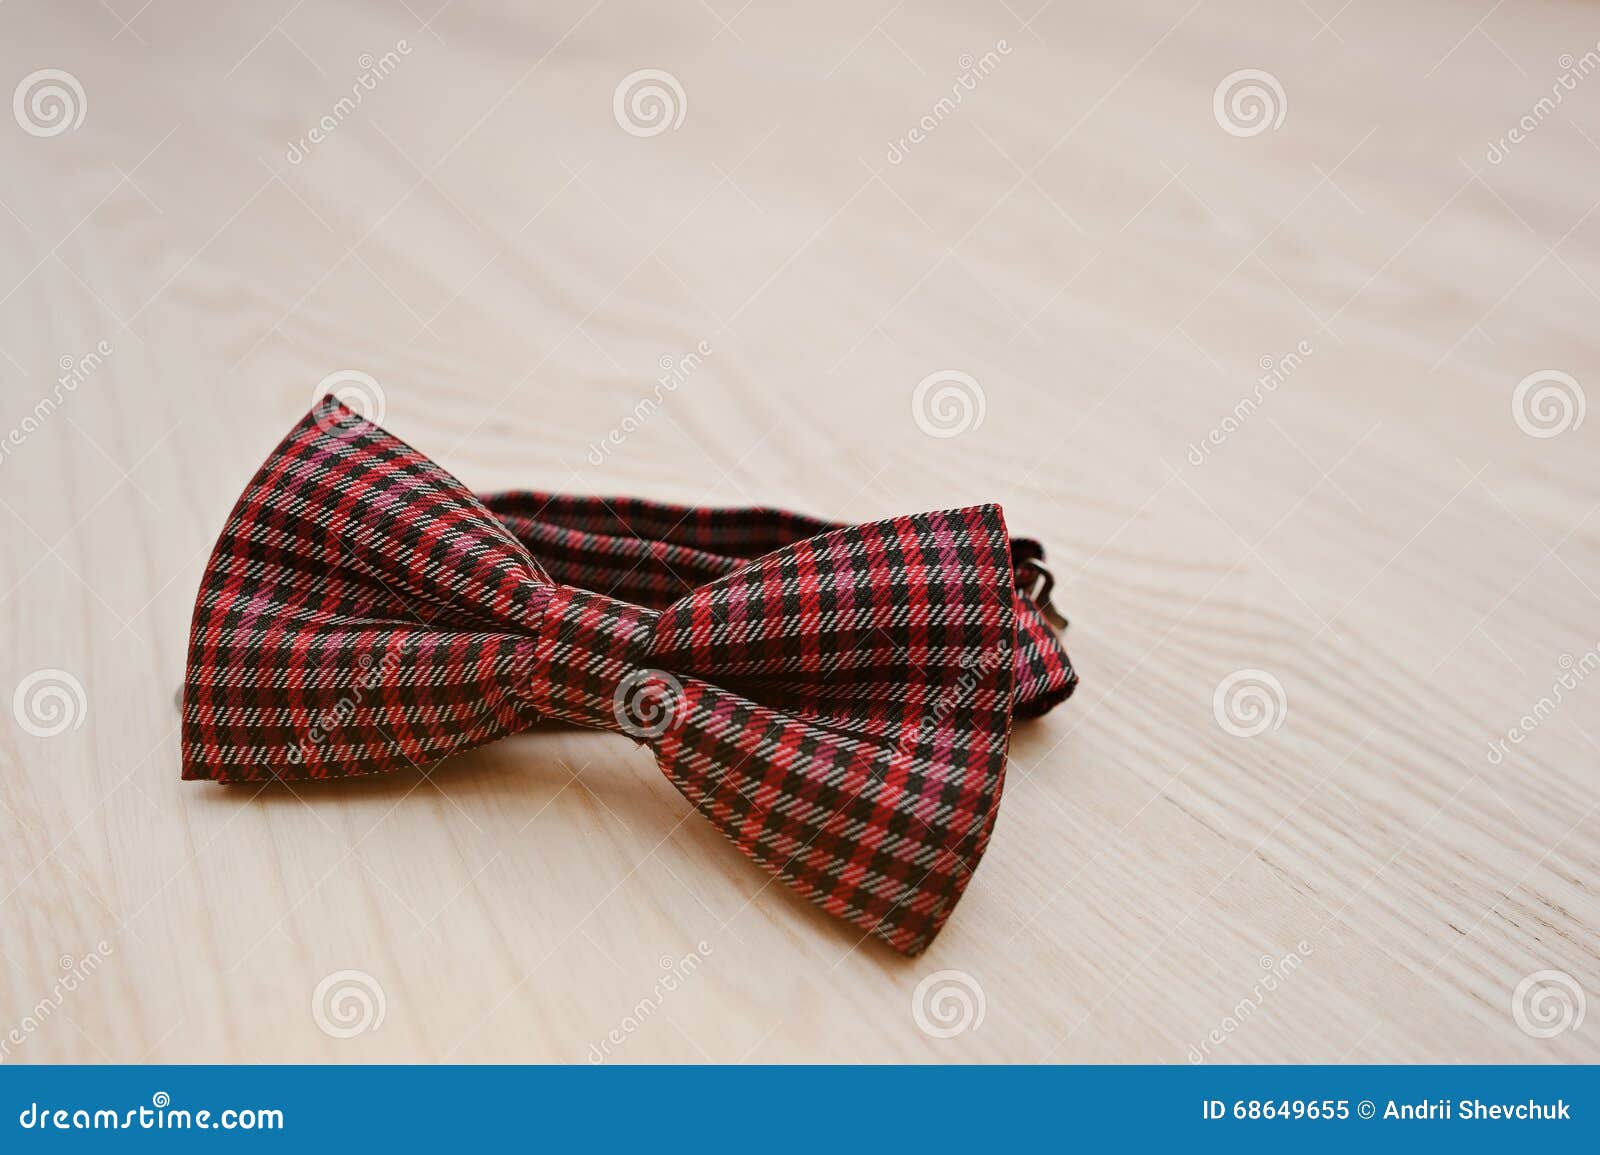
636, 506, 1016, 955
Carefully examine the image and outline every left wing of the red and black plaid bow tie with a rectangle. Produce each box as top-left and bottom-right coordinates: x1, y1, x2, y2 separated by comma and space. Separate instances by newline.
182, 397, 549, 782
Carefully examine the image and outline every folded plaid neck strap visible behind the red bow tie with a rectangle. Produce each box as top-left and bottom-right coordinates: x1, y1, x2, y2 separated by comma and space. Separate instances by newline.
478, 490, 1078, 718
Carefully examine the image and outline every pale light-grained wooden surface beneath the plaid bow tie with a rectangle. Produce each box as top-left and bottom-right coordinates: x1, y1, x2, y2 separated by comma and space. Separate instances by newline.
0, 0, 1600, 1062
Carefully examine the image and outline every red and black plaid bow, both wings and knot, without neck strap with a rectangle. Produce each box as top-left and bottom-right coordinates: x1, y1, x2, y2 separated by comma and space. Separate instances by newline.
182, 397, 1072, 955
